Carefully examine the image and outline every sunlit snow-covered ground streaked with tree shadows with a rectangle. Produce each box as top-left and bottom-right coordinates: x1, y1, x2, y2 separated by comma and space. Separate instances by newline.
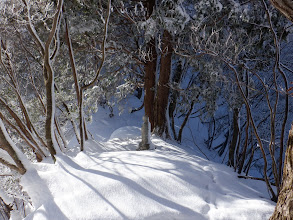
21, 105, 275, 220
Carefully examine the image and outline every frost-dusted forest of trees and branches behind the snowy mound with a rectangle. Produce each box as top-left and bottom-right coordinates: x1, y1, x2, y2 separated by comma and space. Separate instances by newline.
0, 0, 293, 218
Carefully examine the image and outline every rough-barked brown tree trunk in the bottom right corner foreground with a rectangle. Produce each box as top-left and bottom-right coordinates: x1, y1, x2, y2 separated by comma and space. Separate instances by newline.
270, 124, 293, 220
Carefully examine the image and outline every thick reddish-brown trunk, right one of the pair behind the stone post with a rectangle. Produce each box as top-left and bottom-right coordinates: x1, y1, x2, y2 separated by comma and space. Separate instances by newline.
154, 30, 173, 136
